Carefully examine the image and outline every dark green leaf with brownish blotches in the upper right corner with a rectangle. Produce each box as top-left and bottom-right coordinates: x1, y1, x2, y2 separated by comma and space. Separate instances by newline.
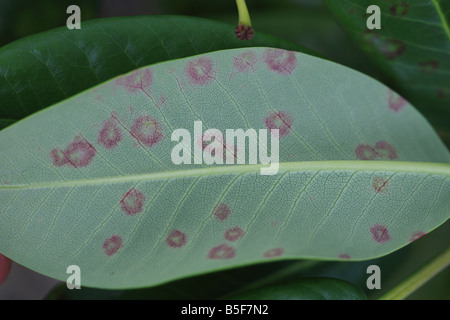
324, 0, 450, 145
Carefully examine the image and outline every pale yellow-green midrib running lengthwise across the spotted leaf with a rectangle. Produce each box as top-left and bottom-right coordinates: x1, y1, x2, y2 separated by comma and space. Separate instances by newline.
0, 160, 450, 190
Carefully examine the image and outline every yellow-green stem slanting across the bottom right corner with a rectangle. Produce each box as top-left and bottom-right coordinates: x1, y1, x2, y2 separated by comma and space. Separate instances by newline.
379, 248, 450, 300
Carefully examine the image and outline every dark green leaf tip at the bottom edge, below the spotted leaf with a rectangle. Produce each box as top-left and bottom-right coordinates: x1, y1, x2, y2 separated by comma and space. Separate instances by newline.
226, 278, 366, 300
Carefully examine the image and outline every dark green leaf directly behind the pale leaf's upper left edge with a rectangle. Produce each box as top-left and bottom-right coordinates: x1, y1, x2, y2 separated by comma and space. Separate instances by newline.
0, 16, 311, 129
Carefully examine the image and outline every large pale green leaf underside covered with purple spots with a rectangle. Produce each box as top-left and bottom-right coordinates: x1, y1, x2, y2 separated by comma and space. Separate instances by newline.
0, 48, 450, 288
